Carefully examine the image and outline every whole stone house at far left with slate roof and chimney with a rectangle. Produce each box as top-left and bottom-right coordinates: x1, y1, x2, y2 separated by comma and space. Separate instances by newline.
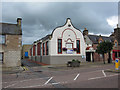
0, 18, 22, 67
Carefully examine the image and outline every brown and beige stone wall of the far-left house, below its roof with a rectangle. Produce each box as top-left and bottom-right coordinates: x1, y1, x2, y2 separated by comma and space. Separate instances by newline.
2, 35, 22, 67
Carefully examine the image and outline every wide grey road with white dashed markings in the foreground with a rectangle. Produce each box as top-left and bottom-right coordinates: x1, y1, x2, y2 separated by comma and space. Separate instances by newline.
2, 61, 118, 88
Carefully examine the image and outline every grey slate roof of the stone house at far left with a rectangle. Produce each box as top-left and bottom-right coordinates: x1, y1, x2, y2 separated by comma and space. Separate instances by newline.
0, 23, 22, 35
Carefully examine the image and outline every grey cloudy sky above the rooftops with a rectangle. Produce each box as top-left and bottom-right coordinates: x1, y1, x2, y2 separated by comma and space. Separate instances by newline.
0, 2, 118, 44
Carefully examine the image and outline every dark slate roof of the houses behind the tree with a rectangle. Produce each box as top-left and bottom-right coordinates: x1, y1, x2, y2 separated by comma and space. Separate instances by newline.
88, 35, 112, 44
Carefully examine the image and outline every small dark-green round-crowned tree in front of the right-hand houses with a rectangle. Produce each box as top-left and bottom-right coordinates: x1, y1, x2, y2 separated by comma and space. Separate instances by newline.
96, 41, 113, 64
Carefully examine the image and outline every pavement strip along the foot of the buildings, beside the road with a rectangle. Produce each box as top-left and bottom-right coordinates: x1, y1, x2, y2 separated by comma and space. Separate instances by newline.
1, 59, 120, 74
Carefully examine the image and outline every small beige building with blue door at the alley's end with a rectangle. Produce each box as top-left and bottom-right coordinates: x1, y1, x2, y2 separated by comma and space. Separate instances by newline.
21, 44, 31, 59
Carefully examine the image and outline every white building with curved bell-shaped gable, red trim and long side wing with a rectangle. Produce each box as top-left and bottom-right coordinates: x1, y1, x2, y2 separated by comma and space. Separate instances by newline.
30, 18, 86, 64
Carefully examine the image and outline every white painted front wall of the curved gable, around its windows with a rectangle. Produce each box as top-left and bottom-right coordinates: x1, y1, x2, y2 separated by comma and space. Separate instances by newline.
49, 19, 86, 55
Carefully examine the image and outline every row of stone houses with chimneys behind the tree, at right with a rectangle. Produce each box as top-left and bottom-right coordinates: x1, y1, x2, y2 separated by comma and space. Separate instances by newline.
83, 24, 120, 62
